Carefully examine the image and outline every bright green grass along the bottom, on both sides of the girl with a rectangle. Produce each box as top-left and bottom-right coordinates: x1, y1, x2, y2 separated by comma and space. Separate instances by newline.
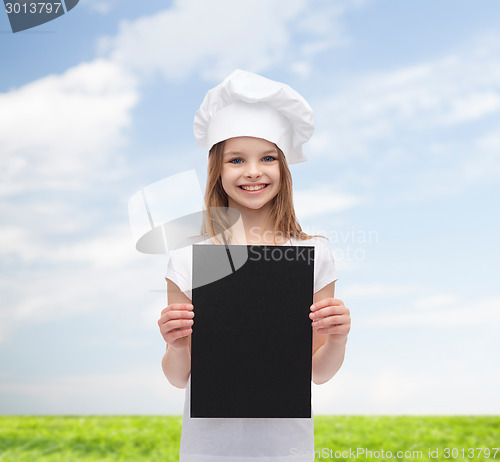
0, 416, 500, 462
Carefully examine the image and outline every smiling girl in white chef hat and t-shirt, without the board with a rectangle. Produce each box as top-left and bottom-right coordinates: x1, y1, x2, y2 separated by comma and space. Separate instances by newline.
158, 70, 350, 462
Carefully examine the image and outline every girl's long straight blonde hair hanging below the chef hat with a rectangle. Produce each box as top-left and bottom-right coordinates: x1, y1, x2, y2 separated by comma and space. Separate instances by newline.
202, 141, 326, 243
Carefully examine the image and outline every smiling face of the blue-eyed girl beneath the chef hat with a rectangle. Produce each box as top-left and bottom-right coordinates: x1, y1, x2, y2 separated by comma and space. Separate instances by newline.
221, 136, 280, 210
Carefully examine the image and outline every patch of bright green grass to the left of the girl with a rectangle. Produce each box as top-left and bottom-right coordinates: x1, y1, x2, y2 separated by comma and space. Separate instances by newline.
0, 416, 182, 462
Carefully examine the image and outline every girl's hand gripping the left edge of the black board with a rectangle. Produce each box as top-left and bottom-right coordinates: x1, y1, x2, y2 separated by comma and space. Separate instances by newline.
158, 303, 194, 349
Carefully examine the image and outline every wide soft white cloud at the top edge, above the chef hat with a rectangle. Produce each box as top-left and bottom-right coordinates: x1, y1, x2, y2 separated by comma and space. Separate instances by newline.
100, 0, 360, 80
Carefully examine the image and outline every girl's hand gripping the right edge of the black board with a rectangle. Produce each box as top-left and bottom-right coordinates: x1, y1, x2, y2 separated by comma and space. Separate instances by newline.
309, 298, 351, 342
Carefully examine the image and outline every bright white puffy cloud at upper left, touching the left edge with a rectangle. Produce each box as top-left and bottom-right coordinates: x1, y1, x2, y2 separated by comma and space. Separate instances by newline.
0, 60, 139, 196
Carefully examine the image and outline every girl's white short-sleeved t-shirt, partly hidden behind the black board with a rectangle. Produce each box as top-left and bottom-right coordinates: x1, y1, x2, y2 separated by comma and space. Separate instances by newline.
166, 238, 337, 462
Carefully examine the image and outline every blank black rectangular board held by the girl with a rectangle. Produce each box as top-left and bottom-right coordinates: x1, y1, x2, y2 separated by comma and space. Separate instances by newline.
191, 245, 314, 418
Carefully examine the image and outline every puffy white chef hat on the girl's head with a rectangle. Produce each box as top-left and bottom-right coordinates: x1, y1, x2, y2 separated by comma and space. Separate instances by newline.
193, 69, 314, 164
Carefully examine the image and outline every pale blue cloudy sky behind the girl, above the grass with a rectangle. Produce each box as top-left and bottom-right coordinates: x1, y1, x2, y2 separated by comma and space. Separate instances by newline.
0, 0, 500, 415
